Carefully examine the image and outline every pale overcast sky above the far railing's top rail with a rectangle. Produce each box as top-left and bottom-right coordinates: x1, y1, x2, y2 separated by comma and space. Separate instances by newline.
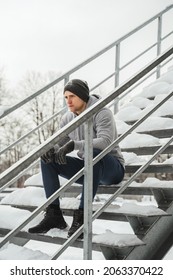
0, 0, 173, 86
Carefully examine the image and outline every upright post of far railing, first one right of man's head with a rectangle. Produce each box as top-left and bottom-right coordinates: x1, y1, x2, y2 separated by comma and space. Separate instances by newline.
114, 43, 120, 114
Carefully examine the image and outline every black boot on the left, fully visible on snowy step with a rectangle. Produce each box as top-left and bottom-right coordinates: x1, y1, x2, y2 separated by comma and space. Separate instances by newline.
28, 205, 67, 233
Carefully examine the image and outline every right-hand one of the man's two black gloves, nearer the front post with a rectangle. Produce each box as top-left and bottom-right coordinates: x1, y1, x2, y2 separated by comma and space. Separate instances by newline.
55, 141, 74, 164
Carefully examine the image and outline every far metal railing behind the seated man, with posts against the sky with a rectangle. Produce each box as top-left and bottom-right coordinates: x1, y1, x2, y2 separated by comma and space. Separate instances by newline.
0, 5, 173, 160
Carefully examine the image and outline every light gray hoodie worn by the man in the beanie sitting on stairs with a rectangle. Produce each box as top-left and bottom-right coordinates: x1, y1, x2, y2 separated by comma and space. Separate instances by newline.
59, 95, 124, 166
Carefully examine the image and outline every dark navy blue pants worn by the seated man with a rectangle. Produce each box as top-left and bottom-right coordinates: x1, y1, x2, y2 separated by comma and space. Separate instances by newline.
41, 149, 124, 208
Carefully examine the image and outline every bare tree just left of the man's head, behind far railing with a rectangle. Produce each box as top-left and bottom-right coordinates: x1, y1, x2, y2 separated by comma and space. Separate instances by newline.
18, 71, 62, 143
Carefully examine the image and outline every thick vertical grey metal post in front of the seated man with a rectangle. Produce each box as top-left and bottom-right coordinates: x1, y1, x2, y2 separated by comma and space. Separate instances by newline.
83, 118, 93, 260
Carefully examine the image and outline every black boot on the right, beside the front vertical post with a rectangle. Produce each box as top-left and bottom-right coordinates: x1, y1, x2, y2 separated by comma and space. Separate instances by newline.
68, 209, 84, 239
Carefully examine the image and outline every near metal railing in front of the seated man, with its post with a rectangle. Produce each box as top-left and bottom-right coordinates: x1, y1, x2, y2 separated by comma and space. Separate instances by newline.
0, 46, 173, 259
